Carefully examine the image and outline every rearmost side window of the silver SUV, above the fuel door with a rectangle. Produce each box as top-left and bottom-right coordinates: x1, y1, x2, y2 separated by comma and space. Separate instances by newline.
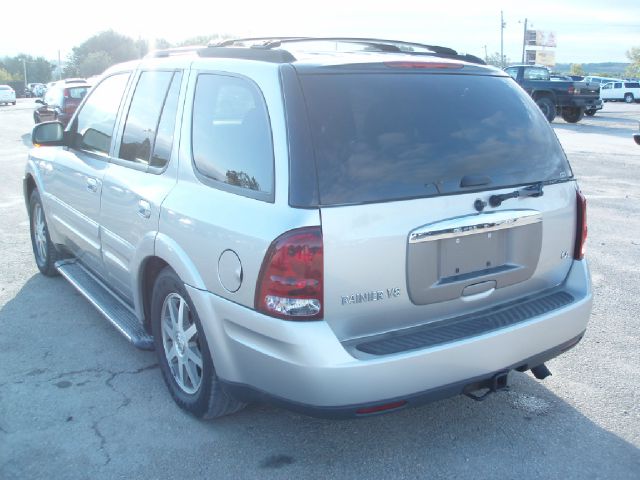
191, 74, 273, 199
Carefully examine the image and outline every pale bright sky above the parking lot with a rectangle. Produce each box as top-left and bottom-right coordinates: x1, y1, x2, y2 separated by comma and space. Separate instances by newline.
0, 0, 640, 63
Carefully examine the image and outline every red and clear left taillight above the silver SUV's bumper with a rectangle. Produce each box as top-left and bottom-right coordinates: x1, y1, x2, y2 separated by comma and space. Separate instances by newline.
255, 227, 324, 320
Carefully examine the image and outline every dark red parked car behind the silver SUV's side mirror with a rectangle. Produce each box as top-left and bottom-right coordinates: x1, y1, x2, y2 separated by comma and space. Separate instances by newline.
33, 83, 91, 127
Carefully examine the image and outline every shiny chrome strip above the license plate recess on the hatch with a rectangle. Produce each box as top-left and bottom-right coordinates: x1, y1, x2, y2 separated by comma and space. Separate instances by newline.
409, 210, 542, 243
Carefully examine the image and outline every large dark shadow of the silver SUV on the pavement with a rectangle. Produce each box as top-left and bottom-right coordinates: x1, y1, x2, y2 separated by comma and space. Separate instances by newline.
0, 274, 640, 479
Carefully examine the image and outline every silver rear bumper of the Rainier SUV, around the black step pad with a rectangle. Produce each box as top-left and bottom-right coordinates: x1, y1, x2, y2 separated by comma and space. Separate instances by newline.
188, 261, 592, 417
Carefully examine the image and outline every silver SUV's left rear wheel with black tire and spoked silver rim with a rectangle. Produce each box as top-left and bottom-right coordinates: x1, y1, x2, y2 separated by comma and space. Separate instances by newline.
151, 267, 246, 418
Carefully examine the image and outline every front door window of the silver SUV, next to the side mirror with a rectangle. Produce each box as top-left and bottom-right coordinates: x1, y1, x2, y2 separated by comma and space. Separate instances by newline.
72, 73, 129, 154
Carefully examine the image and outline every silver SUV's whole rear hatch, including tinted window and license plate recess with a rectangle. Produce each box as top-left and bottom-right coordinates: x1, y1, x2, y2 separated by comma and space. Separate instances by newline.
288, 64, 576, 341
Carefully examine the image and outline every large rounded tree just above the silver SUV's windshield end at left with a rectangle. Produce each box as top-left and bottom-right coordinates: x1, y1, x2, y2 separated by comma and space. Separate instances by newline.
64, 30, 148, 77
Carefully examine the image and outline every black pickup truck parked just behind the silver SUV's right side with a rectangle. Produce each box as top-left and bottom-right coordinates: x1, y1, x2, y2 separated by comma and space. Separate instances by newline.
504, 65, 602, 123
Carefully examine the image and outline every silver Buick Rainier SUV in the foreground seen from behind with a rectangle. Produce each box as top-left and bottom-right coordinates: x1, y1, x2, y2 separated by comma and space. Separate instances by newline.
24, 38, 592, 418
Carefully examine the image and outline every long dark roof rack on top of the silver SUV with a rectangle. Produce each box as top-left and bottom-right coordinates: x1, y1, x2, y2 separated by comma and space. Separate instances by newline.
209, 37, 485, 65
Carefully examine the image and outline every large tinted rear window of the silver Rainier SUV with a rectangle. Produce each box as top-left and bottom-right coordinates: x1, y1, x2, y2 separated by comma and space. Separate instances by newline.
300, 74, 572, 205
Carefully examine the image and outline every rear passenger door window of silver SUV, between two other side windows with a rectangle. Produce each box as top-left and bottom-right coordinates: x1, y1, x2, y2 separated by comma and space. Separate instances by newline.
118, 72, 180, 166
